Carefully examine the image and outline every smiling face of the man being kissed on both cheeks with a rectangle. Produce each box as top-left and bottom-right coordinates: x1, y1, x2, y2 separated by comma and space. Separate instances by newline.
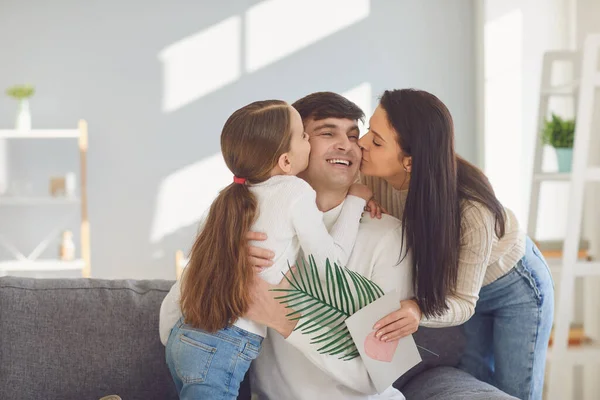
298, 118, 362, 190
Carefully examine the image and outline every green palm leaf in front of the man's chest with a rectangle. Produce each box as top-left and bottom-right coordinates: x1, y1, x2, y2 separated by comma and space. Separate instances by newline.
273, 256, 384, 360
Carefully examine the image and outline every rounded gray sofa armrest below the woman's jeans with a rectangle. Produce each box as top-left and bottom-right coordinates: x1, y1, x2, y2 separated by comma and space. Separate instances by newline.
402, 367, 518, 400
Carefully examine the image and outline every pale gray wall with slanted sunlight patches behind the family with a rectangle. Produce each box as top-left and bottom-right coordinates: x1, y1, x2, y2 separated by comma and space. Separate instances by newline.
0, 0, 477, 278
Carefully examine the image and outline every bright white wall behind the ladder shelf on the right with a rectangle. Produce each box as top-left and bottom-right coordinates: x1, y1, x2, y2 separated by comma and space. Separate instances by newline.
484, 0, 572, 240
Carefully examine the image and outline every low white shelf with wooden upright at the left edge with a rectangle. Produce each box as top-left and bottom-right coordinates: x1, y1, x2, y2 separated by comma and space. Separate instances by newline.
0, 120, 91, 278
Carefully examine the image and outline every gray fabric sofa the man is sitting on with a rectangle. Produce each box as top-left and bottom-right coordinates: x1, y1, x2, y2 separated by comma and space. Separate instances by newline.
0, 277, 512, 400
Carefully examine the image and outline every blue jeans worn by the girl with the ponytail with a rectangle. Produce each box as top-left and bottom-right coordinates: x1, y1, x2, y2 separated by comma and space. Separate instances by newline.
166, 320, 263, 400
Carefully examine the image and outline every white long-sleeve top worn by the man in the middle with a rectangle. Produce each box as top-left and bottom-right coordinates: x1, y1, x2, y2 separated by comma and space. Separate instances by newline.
250, 206, 414, 400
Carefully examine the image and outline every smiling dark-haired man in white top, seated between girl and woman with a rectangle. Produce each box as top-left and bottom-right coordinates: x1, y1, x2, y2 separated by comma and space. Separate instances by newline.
243, 92, 412, 400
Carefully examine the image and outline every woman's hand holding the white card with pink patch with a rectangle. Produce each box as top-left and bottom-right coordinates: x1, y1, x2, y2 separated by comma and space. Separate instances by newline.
373, 300, 422, 342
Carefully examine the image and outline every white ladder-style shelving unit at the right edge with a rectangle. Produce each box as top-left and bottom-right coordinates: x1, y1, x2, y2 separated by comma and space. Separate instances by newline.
528, 35, 600, 400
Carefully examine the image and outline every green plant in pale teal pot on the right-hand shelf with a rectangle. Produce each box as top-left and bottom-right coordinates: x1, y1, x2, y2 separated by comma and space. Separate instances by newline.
542, 113, 575, 172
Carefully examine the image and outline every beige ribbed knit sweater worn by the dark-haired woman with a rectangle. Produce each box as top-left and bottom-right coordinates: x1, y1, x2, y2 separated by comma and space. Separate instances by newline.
362, 177, 525, 328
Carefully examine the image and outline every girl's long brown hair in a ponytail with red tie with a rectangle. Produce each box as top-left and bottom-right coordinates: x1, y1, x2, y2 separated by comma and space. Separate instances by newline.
181, 100, 291, 332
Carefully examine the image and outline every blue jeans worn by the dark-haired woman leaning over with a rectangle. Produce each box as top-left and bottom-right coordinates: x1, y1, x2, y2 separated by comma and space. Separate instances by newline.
459, 238, 554, 400
